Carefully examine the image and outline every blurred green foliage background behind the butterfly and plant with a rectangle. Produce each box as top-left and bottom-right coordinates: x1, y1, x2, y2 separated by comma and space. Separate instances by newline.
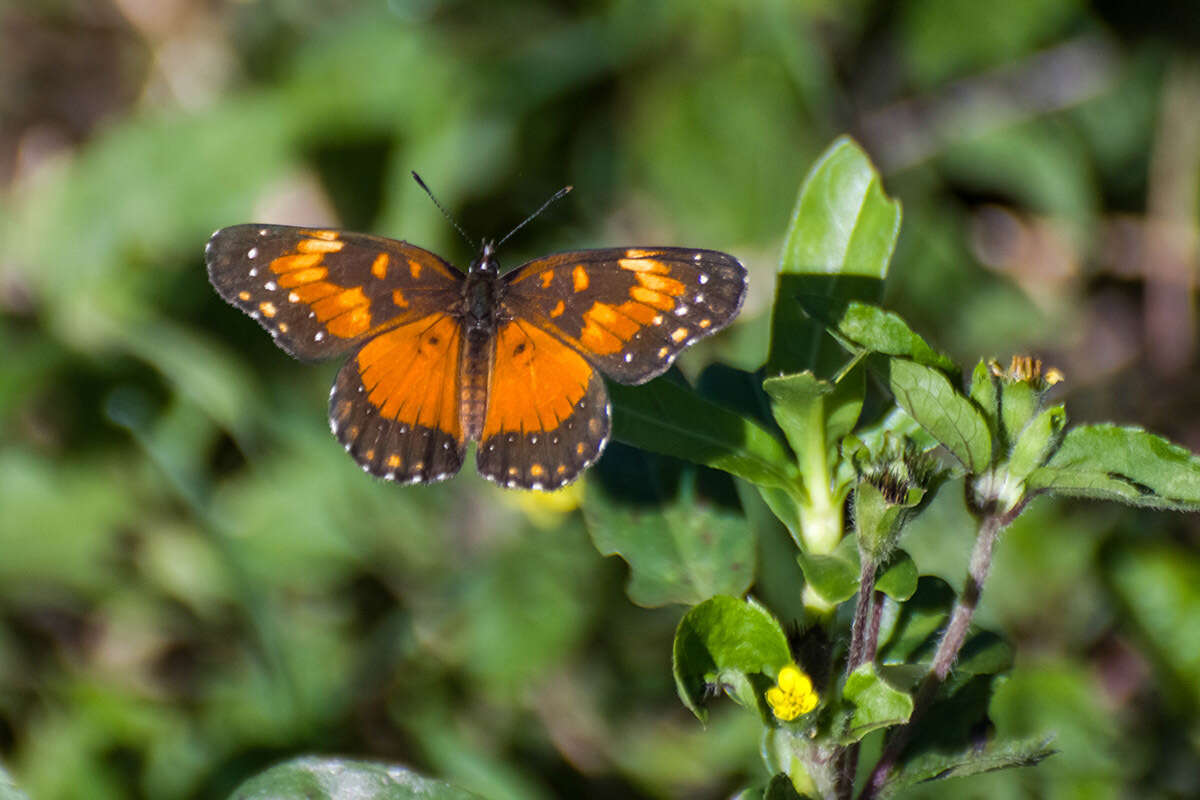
0, 0, 1200, 800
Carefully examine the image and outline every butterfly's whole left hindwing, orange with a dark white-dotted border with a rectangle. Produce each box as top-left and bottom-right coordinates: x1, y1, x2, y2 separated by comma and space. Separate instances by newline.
329, 313, 467, 483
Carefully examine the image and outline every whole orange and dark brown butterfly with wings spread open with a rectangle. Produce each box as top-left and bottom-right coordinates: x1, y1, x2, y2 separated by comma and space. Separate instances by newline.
205, 224, 746, 491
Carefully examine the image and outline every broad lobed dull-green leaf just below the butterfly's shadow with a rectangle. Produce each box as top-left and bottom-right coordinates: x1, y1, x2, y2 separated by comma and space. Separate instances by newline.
583, 479, 755, 608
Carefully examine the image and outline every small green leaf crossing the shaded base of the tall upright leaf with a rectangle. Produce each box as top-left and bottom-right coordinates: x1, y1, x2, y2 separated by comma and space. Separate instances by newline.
800, 297, 958, 373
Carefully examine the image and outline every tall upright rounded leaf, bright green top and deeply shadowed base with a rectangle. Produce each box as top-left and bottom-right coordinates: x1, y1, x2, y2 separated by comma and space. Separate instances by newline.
767, 137, 900, 375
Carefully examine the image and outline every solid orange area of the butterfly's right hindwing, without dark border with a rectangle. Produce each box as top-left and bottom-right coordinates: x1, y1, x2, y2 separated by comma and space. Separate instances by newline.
481, 320, 593, 439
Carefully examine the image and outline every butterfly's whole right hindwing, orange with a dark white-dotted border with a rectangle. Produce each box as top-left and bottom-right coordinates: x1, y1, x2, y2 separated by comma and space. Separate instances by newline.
475, 319, 611, 489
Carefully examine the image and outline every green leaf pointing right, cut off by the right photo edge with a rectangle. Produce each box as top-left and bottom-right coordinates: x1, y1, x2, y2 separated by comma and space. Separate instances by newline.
1025, 425, 1200, 511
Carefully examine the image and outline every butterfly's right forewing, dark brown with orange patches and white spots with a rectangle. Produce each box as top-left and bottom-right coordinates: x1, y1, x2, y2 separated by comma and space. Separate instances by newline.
504, 247, 746, 384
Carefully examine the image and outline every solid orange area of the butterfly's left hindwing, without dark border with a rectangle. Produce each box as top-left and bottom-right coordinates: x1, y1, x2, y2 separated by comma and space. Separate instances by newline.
355, 314, 462, 439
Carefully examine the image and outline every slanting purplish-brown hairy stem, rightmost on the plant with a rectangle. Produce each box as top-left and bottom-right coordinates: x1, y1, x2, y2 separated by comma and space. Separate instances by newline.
858, 509, 1003, 800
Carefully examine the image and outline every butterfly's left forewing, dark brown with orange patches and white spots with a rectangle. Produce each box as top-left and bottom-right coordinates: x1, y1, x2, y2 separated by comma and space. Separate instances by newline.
204, 224, 463, 360
